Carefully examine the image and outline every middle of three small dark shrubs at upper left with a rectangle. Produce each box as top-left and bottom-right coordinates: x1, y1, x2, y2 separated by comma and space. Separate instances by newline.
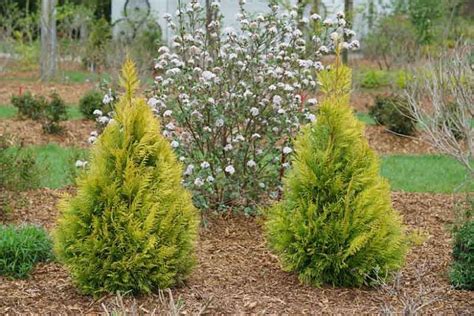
42, 92, 67, 134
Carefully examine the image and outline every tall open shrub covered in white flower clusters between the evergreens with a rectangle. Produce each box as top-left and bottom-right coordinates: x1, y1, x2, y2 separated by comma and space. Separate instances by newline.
148, 1, 359, 211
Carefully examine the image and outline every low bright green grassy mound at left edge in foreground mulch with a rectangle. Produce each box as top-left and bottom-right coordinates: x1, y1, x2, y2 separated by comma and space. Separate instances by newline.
0, 225, 52, 278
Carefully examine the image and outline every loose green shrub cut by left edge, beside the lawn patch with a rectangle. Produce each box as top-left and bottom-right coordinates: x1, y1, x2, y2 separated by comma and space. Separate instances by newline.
0, 135, 45, 191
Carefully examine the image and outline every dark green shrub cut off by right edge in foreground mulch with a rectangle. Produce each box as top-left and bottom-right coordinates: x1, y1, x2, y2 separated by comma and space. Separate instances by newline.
450, 220, 474, 290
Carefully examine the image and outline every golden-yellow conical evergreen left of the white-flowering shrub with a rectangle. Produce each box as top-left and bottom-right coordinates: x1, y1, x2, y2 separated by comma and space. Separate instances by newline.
54, 61, 198, 296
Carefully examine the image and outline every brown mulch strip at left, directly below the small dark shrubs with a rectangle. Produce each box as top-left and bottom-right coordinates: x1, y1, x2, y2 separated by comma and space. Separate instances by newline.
0, 119, 95, 147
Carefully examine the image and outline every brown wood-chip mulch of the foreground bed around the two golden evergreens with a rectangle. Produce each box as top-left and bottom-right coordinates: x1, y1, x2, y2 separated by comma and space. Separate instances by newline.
0, 190, 474, 315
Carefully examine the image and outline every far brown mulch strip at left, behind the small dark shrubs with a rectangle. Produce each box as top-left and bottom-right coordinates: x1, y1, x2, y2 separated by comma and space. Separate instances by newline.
0, 79, 94, 104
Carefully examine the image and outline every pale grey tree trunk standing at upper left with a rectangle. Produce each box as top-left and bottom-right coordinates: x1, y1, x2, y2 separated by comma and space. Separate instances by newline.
40, 0, 57, 81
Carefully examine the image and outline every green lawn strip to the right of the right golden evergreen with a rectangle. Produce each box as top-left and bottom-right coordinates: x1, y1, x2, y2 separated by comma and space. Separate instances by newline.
382, 155, 474, 193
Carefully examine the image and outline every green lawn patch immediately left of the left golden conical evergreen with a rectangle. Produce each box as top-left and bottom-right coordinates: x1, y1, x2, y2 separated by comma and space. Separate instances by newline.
32, 144, 87, 189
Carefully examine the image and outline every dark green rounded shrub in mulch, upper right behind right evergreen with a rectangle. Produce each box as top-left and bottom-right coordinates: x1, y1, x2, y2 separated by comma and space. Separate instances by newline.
369, 95, 416, 135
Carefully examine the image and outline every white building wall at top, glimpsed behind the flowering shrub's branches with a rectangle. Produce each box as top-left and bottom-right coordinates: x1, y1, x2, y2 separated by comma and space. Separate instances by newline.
112, 0, 390, 39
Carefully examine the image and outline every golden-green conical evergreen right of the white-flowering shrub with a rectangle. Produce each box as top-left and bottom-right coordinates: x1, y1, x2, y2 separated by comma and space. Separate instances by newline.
266, 56, 408, 286
